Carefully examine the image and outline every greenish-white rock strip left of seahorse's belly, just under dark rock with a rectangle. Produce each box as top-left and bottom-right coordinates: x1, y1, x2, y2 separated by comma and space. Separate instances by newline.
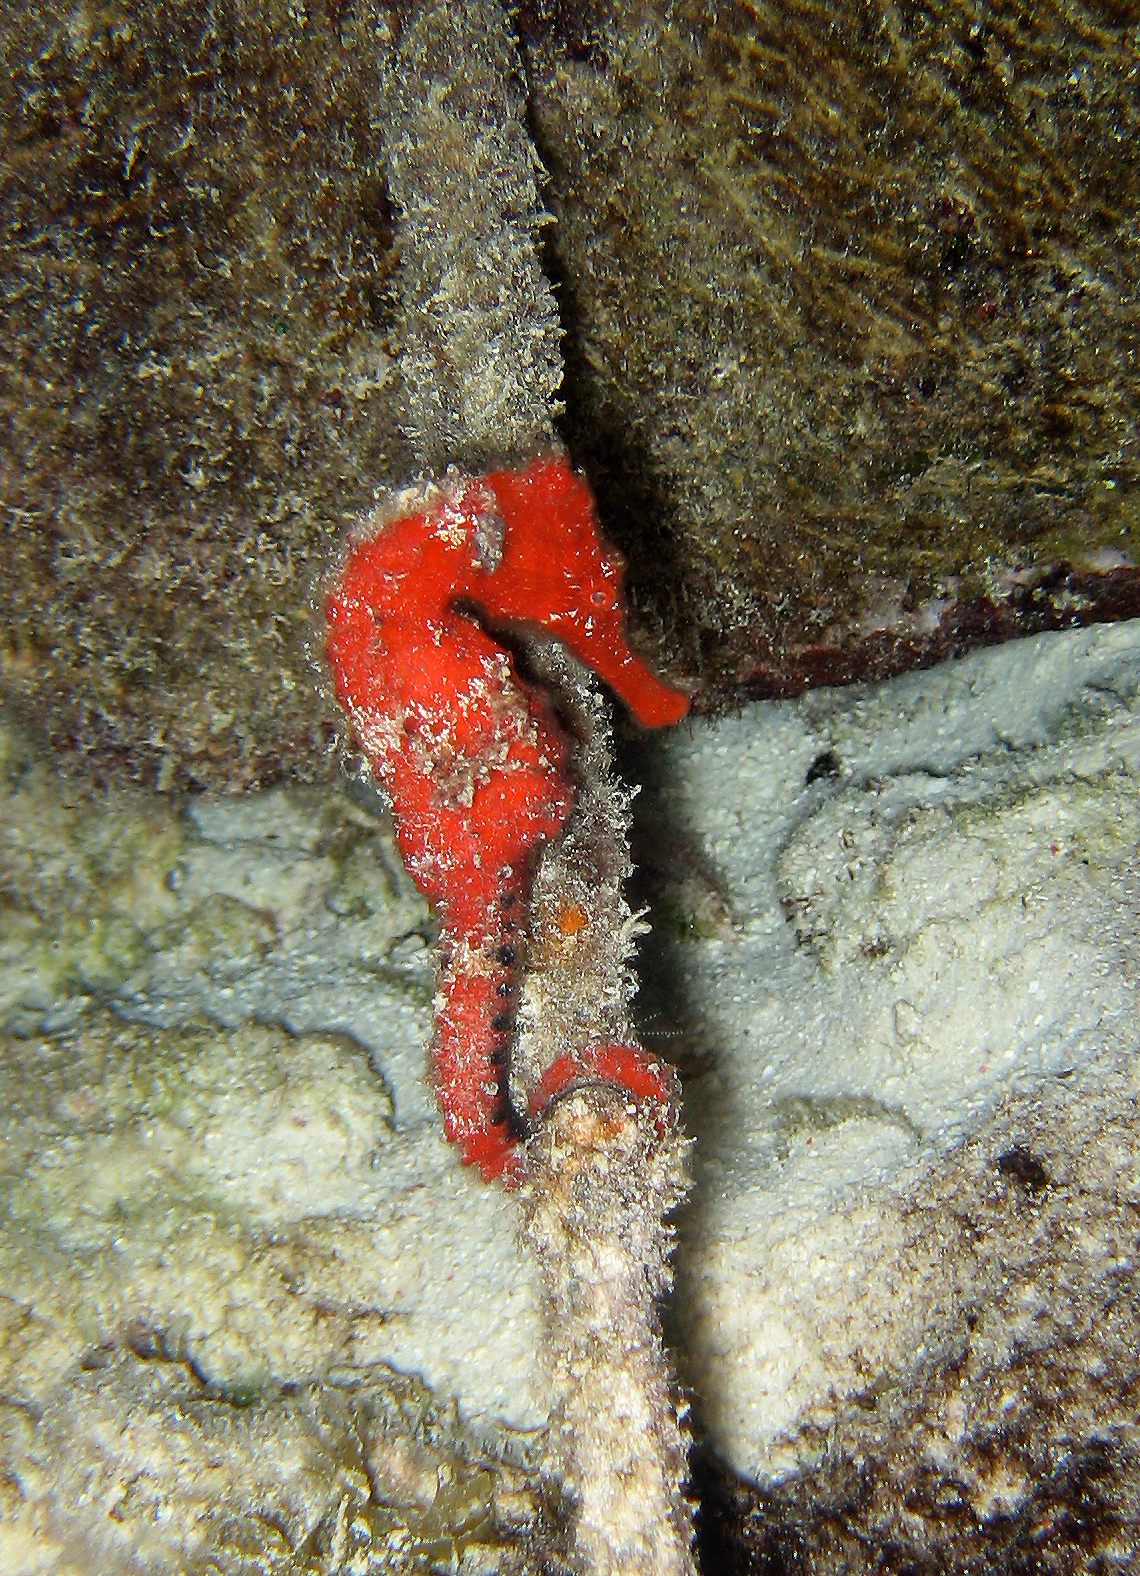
0, 712, 430, 1032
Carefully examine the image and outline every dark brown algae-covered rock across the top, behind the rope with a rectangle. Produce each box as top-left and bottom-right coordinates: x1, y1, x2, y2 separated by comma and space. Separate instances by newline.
0, 0, 1140, 788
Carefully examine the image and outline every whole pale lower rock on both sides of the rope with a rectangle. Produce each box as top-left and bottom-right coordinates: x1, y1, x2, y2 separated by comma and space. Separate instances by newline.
0, 624, 1140, 1576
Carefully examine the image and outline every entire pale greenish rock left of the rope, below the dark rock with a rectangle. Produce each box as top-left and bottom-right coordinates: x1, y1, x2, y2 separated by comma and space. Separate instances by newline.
0, 709, 561, 1576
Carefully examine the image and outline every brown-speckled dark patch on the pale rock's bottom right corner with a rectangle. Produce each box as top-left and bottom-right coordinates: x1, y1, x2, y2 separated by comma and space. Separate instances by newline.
700, 1046, 1140, 1576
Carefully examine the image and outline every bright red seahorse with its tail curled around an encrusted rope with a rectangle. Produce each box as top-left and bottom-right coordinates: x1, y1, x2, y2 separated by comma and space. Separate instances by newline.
325, 455, 687, 1177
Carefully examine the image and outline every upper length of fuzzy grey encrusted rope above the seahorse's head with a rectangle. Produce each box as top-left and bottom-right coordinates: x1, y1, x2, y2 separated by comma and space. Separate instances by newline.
388, 0, 563, 473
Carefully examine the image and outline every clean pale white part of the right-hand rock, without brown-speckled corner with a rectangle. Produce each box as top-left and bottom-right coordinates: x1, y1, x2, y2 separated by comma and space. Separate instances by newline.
656, 626, 1140, 1478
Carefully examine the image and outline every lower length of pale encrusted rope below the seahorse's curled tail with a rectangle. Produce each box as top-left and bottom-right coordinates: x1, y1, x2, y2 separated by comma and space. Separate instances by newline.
523, 1084, 695, 1576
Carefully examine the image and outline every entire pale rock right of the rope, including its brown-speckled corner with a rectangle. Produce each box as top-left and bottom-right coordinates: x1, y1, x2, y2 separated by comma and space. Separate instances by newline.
635, 621, 1140, 1576
